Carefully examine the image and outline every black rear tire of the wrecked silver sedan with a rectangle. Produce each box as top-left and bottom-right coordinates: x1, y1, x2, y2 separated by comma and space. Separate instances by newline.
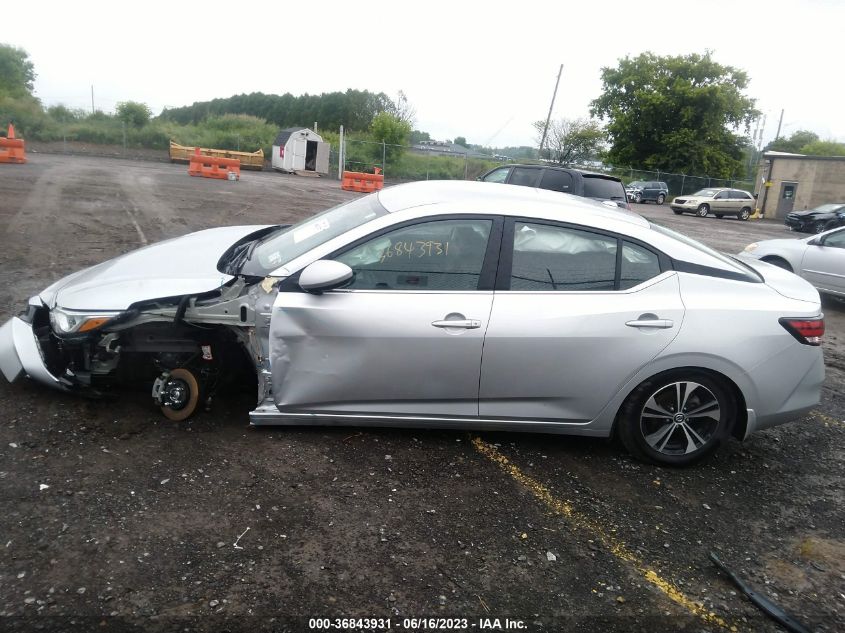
617, 368, 737, 466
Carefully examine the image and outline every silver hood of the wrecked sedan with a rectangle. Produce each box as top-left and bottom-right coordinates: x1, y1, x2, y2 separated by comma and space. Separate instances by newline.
39, 225, 267, 310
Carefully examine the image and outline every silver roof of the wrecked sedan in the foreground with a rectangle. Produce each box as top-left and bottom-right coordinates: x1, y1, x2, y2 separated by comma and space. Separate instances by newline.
378, 180, 649, 227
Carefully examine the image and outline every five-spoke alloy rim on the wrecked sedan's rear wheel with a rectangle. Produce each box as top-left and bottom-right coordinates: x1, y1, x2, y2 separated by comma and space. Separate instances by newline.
640, 381, 722, 455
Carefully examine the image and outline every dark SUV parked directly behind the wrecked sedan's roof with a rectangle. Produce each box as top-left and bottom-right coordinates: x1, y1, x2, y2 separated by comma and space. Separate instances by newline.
479, 165, 630, 209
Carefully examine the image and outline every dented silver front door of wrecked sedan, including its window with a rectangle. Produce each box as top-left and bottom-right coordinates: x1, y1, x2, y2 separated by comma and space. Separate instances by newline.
270, 216, 502, 417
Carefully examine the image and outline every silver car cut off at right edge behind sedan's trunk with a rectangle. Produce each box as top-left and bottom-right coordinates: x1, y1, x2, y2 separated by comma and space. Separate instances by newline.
739, 227, 845, 297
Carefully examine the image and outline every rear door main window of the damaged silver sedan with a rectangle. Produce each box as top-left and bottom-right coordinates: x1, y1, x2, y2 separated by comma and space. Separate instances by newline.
511, 222, 617, 290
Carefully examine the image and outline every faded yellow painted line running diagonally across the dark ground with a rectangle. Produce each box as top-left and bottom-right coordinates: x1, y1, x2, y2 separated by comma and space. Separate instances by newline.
472, 437, 738, 631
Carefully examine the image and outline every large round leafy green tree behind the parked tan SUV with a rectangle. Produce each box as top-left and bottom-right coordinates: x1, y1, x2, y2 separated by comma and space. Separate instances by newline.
590, 51, 758, 178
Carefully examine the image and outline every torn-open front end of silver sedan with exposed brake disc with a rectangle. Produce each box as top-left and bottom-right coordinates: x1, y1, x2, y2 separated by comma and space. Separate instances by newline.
0, 277, 275, 420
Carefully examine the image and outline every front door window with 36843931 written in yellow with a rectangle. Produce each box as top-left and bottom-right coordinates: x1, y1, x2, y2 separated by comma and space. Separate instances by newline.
335, 219, 493, 290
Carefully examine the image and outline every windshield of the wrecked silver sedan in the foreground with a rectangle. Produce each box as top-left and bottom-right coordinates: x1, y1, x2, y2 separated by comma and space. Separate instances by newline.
241, 194, 387, 277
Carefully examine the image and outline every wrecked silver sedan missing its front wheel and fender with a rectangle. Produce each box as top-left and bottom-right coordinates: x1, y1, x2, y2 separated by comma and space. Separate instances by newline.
0, 182, 824, 465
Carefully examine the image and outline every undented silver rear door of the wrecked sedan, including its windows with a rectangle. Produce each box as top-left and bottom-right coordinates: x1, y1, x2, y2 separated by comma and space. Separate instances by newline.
479, 219, 684, 423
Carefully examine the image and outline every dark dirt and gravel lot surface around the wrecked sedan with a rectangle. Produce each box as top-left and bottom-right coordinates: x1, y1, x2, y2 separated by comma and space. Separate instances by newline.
0, 153, 845, 632
